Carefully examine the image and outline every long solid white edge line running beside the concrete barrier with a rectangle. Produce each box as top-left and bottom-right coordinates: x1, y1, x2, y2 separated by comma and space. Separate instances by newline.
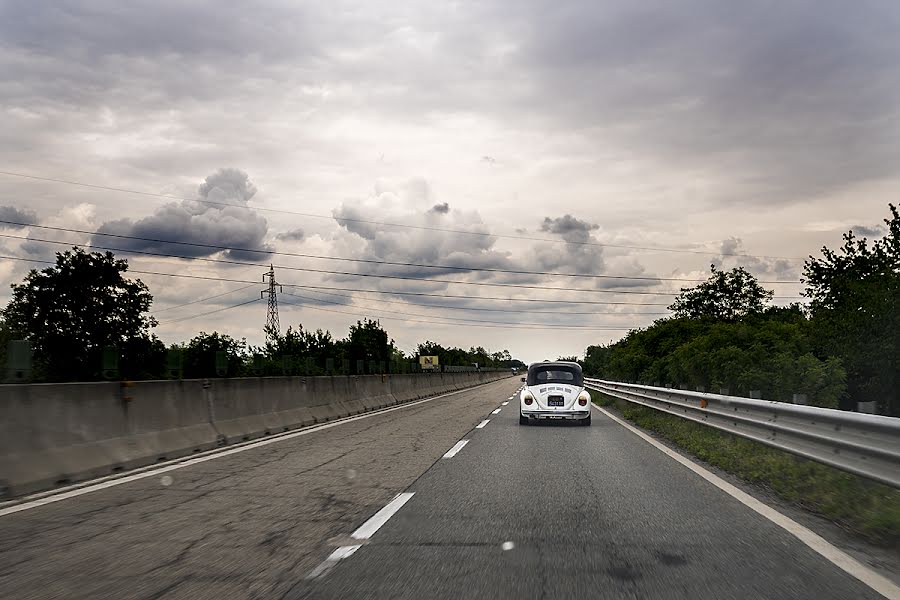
0, 381, 494, 517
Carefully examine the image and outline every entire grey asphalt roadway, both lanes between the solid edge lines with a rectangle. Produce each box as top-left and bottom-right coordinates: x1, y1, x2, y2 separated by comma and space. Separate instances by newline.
0, 379, 896, 600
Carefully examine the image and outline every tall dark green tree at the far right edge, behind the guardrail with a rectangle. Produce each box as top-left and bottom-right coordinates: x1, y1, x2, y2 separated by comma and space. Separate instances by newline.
803, 204, 900, 415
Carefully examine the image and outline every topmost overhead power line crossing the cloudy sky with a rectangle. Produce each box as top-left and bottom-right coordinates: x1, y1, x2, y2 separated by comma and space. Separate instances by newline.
0, 171, 806, 260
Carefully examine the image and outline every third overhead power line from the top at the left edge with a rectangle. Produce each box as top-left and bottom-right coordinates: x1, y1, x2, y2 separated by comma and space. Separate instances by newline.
0, 230, 798, 299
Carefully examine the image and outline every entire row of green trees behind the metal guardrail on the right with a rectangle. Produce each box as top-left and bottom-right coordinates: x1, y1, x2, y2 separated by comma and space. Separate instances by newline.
583, 204, 900, 416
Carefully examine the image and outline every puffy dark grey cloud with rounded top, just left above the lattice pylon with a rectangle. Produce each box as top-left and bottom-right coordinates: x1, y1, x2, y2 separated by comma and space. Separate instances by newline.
93, 169, 271, 260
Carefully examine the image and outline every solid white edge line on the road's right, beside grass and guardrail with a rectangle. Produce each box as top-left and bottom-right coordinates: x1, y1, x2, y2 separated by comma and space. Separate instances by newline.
594, 406, 900, 600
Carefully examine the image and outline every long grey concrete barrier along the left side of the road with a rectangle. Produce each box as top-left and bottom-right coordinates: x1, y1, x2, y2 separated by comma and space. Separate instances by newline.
0, 373, 508, 496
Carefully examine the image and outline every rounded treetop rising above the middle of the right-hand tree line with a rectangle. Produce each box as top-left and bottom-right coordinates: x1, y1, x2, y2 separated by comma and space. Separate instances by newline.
669, 265, 772, 322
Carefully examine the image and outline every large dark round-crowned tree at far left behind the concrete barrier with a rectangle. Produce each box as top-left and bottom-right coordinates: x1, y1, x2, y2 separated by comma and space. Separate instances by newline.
4, 248, 159, 381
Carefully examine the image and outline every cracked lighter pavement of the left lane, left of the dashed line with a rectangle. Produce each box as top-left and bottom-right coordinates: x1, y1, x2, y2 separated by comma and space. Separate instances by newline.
0, 379, 519, 600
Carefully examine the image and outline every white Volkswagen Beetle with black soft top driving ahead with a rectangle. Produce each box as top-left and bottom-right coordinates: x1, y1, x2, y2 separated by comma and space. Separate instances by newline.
519, 362, 591, 425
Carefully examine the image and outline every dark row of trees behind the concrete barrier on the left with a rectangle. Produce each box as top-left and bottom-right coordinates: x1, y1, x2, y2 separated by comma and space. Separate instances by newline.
0, 247, 524, 382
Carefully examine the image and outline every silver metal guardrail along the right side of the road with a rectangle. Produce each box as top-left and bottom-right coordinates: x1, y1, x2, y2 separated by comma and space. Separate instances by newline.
585, 378, 900, 489
